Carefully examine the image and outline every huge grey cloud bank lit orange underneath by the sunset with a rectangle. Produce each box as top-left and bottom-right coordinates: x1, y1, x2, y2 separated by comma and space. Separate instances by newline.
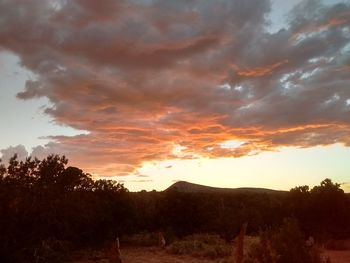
0, 0, 350, 176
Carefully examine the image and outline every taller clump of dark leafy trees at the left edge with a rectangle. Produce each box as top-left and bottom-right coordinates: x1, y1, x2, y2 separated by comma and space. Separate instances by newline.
0, 155, 132, 262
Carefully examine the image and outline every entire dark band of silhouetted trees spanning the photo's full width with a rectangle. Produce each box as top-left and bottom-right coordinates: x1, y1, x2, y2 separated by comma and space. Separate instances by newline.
0, 155, 350, 262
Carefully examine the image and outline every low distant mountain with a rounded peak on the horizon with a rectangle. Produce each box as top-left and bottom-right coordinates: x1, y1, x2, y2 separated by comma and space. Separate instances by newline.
165, 181, 285, 193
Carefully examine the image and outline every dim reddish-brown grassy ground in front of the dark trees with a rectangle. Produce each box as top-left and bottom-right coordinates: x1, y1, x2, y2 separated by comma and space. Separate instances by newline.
65, 233, 350, 263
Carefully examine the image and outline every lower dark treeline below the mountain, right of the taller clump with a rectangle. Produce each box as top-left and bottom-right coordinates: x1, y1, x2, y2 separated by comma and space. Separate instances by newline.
130, 179, 350, 240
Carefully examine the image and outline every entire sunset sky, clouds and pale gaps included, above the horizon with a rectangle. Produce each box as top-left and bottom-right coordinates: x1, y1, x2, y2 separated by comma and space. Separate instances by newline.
0, 0, 350, 192
